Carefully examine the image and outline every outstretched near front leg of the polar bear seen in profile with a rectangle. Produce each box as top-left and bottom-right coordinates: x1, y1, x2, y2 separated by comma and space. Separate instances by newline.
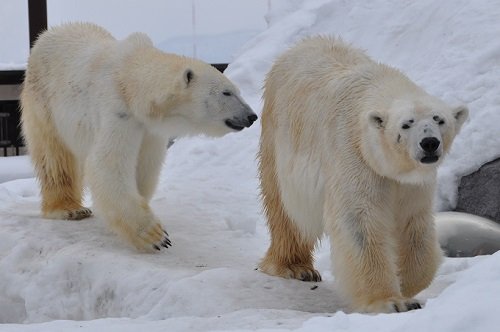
87, 118, 171, 251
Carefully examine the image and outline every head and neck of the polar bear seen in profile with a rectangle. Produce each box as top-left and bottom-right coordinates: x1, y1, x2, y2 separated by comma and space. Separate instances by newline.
118, 45, 257, 138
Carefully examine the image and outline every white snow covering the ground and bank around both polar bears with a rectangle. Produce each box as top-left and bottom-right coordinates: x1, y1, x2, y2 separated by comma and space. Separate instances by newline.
0, 0, 500, 332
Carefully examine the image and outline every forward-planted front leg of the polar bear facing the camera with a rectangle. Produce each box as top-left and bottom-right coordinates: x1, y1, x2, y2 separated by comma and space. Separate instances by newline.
325, 192, 420, 312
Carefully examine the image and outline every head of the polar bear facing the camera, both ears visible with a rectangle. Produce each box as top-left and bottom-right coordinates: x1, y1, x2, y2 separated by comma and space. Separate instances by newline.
364, 95, 468, 183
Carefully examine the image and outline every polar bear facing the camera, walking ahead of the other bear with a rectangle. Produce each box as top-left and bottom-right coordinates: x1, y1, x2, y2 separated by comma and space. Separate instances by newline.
259, 37, 468, 312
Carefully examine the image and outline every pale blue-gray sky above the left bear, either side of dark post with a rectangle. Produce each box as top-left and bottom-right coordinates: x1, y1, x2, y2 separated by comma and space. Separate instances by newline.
0, 0, 276, 63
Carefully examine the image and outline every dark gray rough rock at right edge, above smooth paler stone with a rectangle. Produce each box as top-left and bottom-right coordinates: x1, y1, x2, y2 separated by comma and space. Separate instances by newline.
455, 158, 500, 223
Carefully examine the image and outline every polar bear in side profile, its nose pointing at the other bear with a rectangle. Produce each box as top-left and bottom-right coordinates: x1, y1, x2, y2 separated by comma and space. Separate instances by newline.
21, 23, 257, 251
